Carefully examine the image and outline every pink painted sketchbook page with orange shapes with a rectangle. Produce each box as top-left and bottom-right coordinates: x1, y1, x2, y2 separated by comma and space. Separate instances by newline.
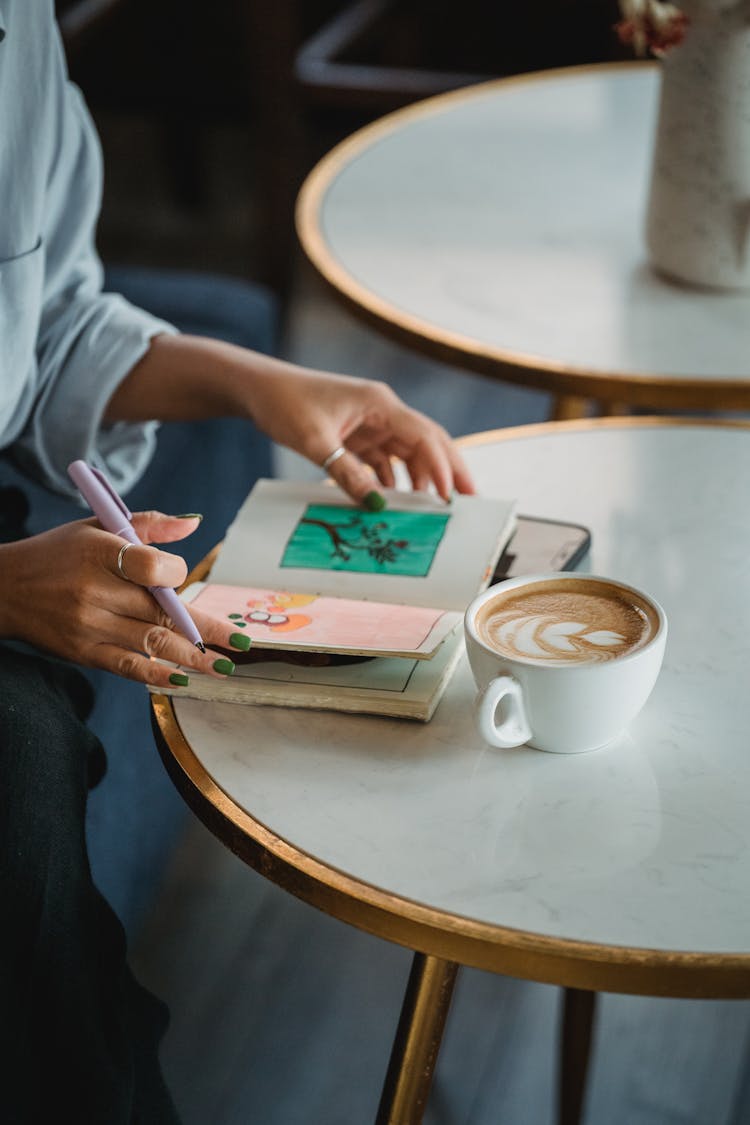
183, 582, 461, 659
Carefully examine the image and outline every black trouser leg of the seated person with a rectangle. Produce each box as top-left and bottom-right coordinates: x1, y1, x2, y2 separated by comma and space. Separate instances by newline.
0, 645, 178, 1125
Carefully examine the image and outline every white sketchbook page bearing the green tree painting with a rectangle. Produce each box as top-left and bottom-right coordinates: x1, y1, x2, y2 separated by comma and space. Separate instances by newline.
210, 480, 515, 611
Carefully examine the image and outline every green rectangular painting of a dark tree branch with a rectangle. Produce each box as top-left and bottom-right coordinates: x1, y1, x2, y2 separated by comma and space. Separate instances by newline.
281, 504, 451, 577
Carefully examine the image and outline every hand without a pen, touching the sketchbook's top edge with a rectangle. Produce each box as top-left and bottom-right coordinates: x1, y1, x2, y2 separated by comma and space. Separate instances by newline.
253, 365, 475, 502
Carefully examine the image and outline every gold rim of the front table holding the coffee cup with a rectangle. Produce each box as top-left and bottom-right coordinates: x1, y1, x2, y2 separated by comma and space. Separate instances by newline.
151, 417, 750, 999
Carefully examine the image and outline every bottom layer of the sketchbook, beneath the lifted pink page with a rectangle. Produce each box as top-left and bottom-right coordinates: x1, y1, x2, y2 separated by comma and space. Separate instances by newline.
148, 626, 463, 722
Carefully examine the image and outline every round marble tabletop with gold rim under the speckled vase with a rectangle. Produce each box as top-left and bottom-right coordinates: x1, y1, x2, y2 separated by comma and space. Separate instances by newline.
297, 63, 750, 411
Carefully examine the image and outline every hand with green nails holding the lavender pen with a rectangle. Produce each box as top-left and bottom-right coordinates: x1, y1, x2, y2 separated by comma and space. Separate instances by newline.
0, 512, 250, 687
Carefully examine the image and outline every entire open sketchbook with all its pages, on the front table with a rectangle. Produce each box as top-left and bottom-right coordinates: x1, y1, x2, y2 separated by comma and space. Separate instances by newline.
150, 480, 515, 719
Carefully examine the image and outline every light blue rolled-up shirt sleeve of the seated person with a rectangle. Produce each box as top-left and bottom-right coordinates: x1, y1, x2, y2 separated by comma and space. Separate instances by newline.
13, 18, 175, 496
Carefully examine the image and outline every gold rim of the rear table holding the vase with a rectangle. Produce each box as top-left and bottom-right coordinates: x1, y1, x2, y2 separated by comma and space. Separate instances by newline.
295, 61, 750, 410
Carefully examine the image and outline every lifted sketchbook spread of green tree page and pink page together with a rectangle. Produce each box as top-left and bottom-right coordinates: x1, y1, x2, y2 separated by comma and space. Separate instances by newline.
176, 480, 514, 659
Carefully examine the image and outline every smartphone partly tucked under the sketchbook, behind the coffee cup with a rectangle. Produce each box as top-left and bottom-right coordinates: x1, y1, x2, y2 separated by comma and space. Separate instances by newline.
493, 515, 591, 582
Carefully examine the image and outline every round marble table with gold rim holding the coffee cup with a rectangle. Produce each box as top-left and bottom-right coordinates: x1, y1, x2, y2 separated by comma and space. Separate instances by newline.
153, 419, 750, 1122
